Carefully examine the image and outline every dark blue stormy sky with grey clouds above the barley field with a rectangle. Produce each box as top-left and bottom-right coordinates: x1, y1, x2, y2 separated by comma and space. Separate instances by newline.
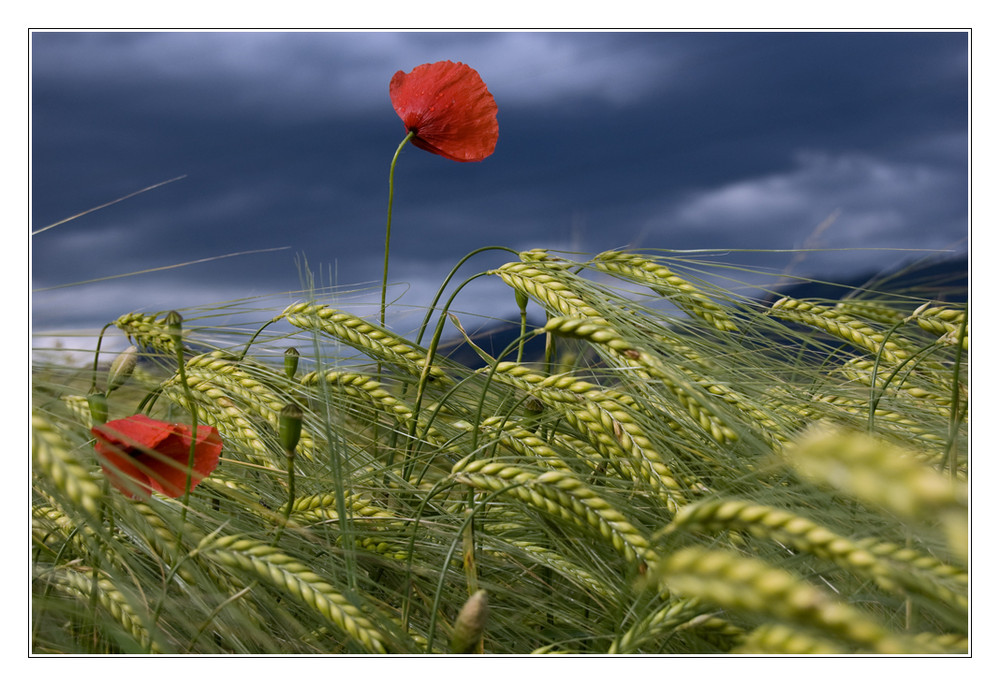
31, 32, 968, 346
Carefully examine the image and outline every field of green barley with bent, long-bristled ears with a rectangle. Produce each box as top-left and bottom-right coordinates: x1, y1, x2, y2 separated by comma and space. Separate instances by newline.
31, 251, 969, 653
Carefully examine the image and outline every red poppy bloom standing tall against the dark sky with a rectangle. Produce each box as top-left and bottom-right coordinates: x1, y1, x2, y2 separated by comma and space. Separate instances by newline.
389, 62, 500, 162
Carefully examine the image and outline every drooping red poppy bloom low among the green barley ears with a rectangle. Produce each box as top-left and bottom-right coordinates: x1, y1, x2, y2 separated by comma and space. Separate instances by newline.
90, 414, 222, 498
